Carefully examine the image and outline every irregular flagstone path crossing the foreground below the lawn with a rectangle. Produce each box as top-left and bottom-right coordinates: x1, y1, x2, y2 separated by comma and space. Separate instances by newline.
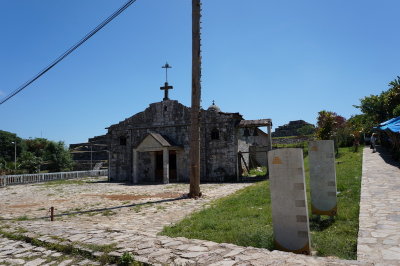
0, 221, 370, 266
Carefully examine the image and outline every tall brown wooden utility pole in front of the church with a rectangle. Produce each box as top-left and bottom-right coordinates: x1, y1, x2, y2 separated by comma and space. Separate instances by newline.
189, 0, 201, 198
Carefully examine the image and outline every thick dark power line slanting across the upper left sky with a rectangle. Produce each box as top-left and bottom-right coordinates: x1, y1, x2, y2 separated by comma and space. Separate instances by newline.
0, 0, 136, 105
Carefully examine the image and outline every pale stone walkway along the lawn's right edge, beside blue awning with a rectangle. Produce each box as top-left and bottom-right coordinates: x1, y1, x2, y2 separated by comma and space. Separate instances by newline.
357, 148, 400, 265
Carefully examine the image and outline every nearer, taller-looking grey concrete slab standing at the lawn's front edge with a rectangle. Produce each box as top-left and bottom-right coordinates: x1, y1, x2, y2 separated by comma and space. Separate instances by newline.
268, 149, 310, 255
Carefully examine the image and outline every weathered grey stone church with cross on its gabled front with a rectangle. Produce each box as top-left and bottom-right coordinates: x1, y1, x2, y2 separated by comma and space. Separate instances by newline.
106, 78, 272, 184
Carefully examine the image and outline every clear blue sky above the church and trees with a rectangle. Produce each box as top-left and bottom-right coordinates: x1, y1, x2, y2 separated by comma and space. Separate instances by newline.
0, 0, 400, 144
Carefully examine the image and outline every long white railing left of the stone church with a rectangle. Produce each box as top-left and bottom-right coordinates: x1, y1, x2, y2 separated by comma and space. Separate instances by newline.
0, 170, 108, 187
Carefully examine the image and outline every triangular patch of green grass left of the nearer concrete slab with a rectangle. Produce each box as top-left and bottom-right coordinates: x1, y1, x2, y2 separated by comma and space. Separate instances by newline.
162, 181, 273, 249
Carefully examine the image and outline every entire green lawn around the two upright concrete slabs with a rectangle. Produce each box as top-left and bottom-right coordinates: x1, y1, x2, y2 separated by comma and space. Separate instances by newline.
162, 148, 362, 259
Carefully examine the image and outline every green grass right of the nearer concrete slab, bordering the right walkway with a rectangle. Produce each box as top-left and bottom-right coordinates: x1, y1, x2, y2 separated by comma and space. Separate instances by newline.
306, 147, 363, 259
